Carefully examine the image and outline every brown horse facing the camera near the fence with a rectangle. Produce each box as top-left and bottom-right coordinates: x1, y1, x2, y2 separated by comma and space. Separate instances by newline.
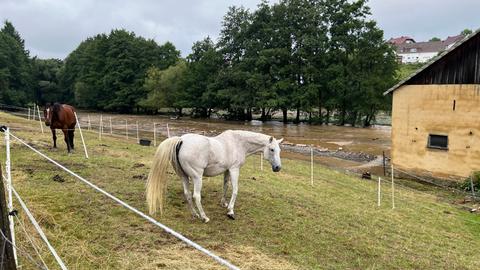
43, 103, 77, 153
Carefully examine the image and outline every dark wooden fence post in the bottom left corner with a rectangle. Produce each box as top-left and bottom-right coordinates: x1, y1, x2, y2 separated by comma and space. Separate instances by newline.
0, 166, 17, 269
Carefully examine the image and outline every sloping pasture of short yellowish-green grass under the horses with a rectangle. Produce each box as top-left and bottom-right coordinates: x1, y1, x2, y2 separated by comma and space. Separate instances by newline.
0, 110, 480, 269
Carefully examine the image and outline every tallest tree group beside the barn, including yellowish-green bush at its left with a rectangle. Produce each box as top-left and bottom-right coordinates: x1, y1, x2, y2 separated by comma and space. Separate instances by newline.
143, 0, 397, 125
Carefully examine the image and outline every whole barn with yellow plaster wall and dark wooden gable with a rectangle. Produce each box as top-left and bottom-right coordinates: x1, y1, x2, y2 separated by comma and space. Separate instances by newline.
384, 31, 480, 180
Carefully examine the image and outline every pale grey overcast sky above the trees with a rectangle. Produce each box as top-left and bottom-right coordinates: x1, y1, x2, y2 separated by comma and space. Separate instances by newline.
0, 0, 480, 59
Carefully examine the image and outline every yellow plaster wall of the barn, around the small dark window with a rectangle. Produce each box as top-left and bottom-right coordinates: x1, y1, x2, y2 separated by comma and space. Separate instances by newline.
392, 85, 480, 179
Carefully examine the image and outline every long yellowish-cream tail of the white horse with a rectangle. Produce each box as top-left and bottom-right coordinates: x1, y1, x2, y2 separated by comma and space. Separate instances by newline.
147, 137, 182, 215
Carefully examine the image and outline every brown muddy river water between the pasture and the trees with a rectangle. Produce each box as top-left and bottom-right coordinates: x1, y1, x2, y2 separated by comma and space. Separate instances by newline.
79, 112, 391, 174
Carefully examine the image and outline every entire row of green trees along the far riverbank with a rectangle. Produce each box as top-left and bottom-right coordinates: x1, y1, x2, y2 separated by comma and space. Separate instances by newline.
0, 0, 397, 125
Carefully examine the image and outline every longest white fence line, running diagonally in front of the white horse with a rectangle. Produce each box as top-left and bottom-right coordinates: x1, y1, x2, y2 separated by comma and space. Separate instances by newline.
5, 130, 239, 270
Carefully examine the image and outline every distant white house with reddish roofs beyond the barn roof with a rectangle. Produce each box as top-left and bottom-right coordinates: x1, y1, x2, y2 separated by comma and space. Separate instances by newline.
388, 35, 465, 64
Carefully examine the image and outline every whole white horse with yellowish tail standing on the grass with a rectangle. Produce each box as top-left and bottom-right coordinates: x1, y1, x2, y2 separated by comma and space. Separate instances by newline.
147, 130, 283, 223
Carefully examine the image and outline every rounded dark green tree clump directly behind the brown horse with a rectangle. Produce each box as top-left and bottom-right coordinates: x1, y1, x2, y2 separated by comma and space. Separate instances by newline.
60, 30, 180, 112
